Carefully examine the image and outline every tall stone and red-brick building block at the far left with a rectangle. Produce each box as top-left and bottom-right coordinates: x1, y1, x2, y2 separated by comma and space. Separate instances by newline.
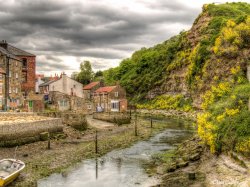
0, 41, 36, 110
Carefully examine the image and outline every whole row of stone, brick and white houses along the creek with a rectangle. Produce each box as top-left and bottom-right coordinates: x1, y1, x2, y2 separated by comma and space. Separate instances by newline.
0, 41, 127, 113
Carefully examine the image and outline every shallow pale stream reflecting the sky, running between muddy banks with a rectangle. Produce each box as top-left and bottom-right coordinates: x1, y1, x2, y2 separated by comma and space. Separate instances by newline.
38, 121, 191, 187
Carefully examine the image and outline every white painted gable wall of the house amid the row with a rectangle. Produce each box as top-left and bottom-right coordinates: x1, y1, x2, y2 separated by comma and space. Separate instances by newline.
49, 74, 83, 98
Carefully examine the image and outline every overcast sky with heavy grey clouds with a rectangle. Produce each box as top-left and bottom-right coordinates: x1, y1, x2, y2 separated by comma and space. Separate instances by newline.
0, 0, 250, 75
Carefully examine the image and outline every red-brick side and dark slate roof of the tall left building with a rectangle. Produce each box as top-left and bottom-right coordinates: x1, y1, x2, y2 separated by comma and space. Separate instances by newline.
0, 41, 36, 97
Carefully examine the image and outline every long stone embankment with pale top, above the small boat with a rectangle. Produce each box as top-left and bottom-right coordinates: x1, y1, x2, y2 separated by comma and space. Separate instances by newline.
0, 113, 63, 147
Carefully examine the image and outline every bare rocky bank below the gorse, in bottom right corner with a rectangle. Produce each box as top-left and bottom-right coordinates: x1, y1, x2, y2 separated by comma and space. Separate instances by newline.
148, 137, 250, 187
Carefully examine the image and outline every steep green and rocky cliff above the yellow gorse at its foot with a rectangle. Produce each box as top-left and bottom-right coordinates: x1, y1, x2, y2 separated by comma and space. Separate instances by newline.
104, 3, 250, 108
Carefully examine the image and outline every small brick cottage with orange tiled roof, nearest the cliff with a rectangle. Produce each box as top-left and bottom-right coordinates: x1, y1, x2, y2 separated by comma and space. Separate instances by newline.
93, 85, 127, 112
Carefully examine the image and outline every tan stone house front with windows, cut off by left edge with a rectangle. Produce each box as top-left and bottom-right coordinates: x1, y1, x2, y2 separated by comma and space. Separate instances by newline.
0, 45, 24, 110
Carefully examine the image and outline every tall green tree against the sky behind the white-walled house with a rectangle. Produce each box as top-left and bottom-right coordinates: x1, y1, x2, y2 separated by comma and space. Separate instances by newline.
76, 61, 94, 84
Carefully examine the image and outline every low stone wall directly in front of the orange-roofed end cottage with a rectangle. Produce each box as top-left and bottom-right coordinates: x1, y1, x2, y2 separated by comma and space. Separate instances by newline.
93, 112, 131, 125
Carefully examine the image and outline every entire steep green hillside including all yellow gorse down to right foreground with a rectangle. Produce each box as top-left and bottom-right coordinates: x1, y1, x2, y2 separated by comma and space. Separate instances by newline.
104, 3, 250, 156
